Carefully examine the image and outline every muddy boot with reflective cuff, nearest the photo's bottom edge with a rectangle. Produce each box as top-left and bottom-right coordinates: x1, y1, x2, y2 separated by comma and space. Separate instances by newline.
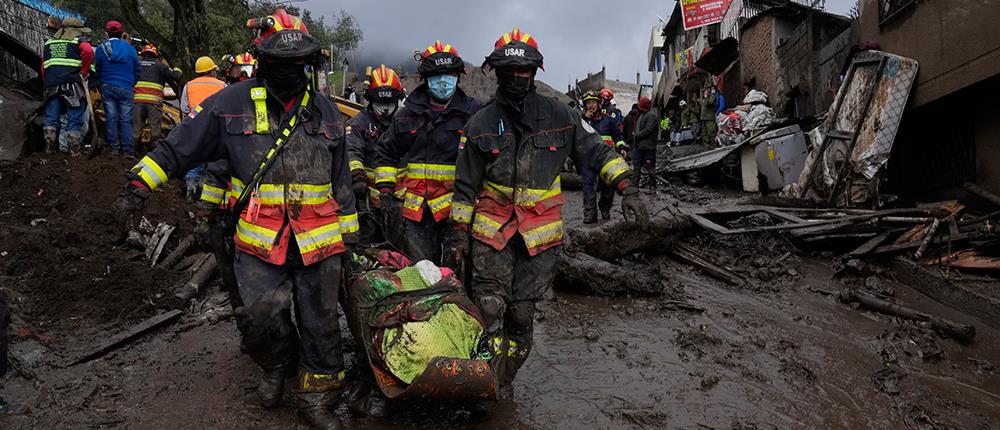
295, 370, 344, 430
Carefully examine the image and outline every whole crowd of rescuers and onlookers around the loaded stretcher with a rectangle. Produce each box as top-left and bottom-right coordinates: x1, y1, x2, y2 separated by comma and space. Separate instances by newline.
44, 9, 659, 428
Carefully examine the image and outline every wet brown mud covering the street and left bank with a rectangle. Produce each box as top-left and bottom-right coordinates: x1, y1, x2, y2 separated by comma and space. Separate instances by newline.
0, 157, 1000, 429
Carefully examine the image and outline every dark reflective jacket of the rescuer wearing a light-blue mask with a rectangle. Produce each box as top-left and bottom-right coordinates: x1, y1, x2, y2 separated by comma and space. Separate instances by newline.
375, 85, 481, 222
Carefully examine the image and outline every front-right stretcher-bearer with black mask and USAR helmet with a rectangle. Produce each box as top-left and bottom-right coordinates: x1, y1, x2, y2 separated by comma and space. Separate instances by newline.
451, 28, 648, 397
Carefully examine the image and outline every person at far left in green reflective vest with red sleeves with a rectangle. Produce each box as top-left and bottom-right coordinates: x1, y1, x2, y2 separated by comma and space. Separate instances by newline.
42, 17, 94, 155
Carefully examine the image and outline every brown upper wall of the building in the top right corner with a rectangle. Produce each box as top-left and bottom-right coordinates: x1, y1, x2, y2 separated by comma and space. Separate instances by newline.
861, 0, 1000, 106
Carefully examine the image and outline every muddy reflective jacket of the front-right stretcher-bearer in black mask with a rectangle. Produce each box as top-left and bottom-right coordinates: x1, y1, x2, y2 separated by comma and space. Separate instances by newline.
451, 92, 629, 255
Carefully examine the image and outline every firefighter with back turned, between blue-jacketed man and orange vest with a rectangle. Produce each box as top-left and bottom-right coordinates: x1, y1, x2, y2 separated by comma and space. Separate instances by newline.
132, 44, 181, 152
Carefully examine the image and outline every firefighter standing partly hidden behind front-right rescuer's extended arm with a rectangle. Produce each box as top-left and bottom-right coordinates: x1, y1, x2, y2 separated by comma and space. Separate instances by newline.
577, 91, 628, 224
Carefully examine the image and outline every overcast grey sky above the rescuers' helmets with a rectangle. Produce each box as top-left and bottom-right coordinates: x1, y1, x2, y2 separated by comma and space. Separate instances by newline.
295, 0, 854, 91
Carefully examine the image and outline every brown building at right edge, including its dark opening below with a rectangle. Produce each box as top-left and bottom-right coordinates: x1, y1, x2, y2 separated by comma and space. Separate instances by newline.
860, 0, 1000, 197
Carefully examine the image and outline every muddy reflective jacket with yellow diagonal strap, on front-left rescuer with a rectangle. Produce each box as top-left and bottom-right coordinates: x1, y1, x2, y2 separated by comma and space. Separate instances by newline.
130, 79, 358, 265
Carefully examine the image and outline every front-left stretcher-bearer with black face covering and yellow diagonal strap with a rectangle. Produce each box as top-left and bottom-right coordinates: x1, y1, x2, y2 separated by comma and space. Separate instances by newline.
114, 9, 358, 429
